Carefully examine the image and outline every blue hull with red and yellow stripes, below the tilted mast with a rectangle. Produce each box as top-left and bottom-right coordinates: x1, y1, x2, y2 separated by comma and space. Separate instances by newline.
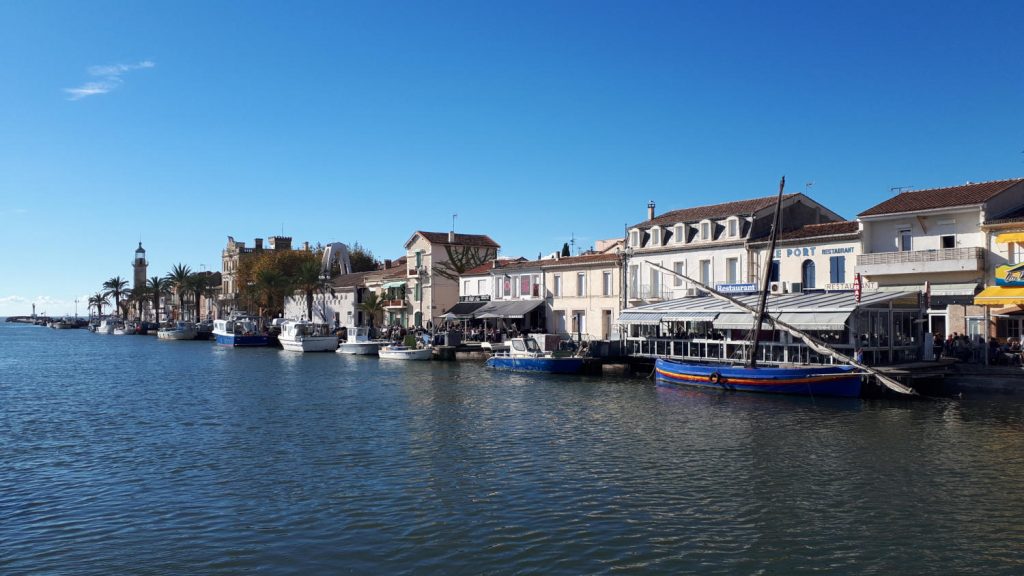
654, 359, 861, 398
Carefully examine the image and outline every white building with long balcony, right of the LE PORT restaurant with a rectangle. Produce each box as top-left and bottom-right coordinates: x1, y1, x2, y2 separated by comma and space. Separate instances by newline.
855, 178, 1024, 337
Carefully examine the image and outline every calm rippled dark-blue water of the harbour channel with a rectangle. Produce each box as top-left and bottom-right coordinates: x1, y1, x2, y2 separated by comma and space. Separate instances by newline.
0, 324, 1024, 574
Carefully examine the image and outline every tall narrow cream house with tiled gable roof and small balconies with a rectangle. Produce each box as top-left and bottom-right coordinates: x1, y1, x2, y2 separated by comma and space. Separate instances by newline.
397, 231, 501, 328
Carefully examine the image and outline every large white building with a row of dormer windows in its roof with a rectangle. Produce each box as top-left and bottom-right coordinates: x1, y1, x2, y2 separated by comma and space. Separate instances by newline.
624, 194, 843, 307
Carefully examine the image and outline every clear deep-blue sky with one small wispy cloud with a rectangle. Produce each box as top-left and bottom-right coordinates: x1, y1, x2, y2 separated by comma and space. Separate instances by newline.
0, 0, 1024, 316
